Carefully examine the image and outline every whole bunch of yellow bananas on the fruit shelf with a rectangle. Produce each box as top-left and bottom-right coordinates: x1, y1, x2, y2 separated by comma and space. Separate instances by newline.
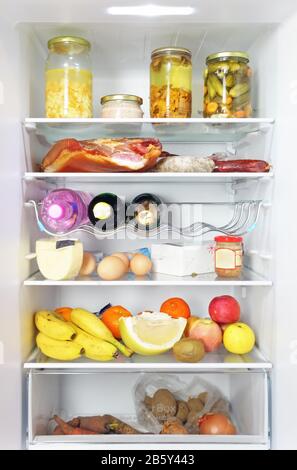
35, 309, 132, 361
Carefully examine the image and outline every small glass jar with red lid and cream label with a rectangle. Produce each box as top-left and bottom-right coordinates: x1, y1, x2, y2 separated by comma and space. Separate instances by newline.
215, 236, 243, 277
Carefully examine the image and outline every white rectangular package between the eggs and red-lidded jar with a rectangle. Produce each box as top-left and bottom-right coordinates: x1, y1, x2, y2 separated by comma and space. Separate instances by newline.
151, 241, 214, 276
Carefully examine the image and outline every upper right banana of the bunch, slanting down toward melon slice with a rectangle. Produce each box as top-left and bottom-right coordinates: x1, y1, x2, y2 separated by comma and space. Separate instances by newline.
71, 308, 133, 357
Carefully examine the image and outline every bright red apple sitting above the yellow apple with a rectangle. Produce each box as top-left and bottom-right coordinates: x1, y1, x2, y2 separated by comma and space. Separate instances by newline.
208, 295, 240, 323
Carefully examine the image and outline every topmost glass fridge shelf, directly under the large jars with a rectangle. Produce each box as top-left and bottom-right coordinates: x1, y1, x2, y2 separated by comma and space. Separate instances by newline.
23, 118, 274, 144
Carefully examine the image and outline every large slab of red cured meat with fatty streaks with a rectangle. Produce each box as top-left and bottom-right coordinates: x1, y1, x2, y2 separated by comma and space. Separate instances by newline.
41, 138, 162, 173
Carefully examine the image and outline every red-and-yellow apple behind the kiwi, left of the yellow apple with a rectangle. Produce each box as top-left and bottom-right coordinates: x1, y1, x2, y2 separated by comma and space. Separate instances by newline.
188, 318, 223, 352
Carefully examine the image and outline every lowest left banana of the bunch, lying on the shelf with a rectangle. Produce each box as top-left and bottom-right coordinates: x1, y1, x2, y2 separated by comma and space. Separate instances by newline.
36, 333, 84, 361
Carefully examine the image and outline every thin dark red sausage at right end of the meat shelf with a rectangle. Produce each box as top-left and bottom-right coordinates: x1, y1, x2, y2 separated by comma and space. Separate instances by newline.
213, 158, 270, 173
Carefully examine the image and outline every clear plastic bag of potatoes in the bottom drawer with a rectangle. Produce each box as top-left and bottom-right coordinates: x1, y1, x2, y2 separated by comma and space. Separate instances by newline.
134, 374, 230, 434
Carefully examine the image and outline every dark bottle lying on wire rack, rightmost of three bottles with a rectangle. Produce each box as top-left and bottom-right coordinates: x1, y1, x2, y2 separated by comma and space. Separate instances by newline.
128, 193, 162, 230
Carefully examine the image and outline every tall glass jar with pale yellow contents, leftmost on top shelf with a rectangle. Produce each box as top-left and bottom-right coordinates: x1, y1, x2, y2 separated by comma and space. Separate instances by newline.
45, 36, 93, 118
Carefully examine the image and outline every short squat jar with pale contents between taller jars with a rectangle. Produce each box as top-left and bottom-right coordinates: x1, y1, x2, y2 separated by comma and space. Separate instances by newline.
101, 94, 143, 119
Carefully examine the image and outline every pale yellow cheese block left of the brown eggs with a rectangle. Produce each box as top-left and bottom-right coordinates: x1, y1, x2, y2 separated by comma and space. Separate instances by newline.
36, 238, 83, 281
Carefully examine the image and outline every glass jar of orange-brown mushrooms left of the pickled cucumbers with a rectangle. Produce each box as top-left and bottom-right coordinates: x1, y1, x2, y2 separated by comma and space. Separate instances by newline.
150, 47, 192, 118
